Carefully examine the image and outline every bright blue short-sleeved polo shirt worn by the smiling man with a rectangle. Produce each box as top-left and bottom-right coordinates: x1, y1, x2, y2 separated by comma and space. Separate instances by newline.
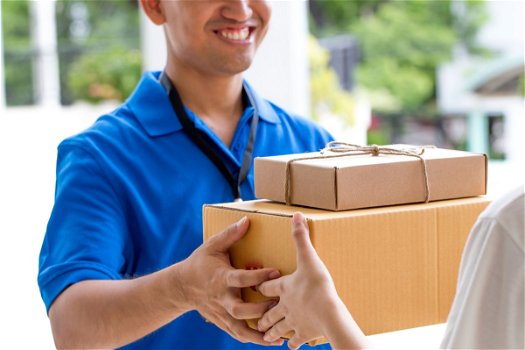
38, 72, 331, 349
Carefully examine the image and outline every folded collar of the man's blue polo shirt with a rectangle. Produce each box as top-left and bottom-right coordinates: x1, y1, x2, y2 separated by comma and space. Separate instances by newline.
126, 71, 280, 136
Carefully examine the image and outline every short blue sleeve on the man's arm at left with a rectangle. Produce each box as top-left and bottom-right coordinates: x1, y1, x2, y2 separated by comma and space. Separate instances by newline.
38, 144, 127, 311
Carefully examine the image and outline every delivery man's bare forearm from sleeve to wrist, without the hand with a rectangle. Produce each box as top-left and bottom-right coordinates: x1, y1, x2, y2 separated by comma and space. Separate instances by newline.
49, 263, 191, 349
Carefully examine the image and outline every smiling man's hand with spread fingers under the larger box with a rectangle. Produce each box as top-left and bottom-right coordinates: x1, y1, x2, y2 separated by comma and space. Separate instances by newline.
181, 217, 282, 345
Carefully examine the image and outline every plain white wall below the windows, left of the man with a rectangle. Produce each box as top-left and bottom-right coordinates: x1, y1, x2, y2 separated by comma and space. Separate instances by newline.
0, 106, 102, 350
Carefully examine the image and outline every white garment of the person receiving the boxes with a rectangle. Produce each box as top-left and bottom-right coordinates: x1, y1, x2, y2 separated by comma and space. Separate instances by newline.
441, 187, 525, 349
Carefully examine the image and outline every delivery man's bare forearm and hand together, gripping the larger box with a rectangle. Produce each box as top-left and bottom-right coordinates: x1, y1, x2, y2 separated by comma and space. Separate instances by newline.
49, 218, 280, 348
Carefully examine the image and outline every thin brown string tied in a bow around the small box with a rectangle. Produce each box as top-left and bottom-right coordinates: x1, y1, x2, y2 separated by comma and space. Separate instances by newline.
284, 141, 434, 205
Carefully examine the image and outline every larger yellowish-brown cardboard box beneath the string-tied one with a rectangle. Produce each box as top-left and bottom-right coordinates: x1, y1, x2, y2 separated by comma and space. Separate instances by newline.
203, 197, 489, 342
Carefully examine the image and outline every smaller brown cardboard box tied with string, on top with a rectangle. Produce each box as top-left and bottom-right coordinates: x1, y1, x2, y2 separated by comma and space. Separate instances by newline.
254, 146, 487, 210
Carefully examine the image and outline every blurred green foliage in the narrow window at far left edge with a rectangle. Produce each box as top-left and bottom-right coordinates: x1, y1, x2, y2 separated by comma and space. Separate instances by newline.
1, 0, 34, 106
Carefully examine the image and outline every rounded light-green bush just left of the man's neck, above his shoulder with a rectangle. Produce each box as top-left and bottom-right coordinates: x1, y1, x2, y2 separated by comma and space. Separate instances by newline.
68, 47, 142, 103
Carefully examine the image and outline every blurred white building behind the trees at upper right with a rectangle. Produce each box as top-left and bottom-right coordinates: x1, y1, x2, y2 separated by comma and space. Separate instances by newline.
437, 1, 525, 165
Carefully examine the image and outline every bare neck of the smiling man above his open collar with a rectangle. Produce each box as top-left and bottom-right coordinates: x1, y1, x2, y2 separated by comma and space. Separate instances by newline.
166, 67, 243, 146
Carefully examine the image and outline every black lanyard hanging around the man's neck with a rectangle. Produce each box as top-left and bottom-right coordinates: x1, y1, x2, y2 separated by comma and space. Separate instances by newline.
159, 72, 259, 201
